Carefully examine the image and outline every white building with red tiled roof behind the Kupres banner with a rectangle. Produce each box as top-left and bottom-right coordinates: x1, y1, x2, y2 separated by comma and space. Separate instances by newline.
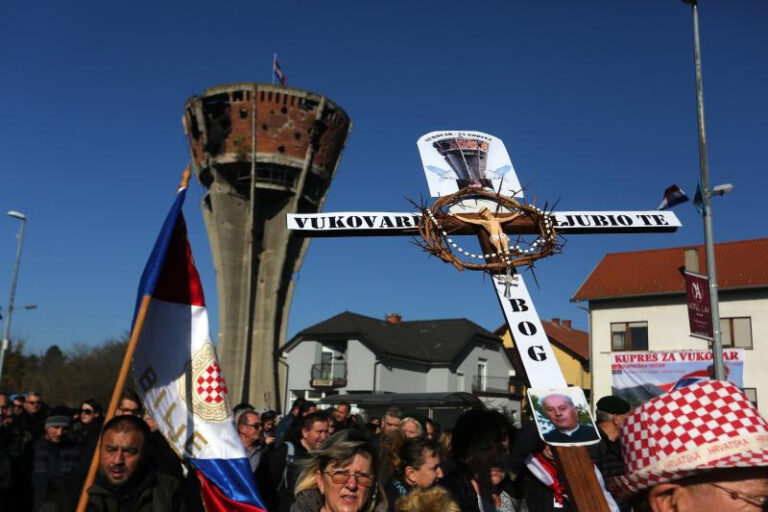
572, 238, 768, 415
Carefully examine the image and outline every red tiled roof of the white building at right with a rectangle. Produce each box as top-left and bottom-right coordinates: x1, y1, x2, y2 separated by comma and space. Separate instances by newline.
571, 238, 768, 300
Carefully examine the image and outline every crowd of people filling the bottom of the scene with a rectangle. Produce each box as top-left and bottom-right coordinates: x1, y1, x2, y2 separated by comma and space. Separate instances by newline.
0, 381, 768, 512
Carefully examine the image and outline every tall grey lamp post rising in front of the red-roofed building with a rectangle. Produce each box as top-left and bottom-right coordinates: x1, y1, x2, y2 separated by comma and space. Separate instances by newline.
683, 0, 725, 380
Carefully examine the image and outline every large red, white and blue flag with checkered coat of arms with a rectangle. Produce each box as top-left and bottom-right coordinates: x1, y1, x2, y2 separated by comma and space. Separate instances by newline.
133, 170, 266, 512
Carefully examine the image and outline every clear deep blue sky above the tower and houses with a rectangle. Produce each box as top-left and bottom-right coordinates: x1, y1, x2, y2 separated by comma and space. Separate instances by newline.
0, 0, 768, 352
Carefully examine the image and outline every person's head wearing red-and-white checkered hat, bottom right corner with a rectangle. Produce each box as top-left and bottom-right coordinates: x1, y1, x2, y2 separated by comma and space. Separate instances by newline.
608, 381, 768, 512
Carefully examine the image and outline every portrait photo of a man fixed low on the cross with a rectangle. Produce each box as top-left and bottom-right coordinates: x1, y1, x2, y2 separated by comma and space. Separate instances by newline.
534, 388, 600, 445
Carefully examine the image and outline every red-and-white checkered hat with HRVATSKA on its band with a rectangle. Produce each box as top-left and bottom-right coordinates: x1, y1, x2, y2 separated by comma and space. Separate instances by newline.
608, 381, 768, 497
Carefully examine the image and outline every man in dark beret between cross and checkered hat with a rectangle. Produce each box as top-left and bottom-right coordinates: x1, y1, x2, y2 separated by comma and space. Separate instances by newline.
587, 395, 632, 512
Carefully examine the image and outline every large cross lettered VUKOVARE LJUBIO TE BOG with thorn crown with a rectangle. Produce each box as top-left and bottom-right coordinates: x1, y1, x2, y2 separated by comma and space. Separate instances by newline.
287, 130, 680, 512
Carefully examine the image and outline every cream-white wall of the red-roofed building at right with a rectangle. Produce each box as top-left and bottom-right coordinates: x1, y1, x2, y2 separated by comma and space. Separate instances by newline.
590, 290, 768, 415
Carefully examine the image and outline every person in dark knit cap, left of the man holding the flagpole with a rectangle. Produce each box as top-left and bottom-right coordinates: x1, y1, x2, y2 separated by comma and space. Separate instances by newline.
32, 406, 80, 510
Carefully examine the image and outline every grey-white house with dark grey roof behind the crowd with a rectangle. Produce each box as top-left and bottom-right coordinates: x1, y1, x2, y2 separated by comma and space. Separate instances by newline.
279, 311, 520, 417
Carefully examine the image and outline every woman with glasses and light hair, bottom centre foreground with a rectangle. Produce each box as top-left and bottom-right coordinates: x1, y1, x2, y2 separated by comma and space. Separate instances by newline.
291, 429, 383, 512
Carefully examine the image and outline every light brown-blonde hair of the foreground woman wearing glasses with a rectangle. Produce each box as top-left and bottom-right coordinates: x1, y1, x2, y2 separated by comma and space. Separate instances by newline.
294, 429, 383, 512
